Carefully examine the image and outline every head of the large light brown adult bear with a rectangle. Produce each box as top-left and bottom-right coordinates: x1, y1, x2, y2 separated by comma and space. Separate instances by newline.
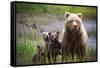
64, 12, 82, 32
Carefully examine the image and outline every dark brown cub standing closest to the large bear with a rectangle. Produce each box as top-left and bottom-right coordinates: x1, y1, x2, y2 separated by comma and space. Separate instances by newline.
48, 32, 61, 62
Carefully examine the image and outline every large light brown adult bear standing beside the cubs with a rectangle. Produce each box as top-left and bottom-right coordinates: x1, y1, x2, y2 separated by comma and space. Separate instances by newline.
61, 12, 88, 60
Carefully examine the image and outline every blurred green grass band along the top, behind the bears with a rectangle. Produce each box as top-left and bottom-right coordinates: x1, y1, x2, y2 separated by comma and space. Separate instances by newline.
16, 3, 96, 18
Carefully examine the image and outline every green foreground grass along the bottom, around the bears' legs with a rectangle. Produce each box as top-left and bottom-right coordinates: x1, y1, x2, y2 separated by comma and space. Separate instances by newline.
16, 35, 96, 65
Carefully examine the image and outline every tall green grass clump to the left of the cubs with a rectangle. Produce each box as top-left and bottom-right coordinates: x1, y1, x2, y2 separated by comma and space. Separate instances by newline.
16, 32, 44, 65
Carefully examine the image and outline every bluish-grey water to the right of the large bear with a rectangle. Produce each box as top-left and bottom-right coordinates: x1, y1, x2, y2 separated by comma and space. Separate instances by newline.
84, 20, 97, 48
